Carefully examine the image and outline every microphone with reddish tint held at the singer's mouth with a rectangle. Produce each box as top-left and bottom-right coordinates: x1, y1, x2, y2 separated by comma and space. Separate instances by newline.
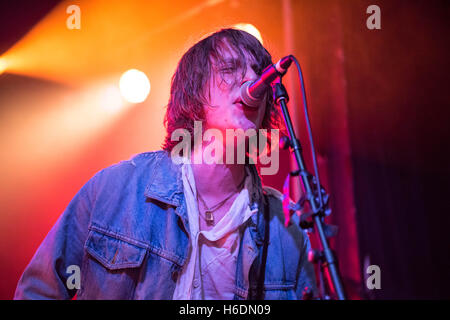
240, 56, 292, 108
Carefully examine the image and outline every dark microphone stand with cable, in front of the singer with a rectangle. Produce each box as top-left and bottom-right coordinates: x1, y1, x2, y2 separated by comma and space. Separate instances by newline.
272, 77, 346, 300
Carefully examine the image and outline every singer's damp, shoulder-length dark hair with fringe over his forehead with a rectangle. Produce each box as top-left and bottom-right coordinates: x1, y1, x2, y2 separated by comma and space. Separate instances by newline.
163, 29, 280, 152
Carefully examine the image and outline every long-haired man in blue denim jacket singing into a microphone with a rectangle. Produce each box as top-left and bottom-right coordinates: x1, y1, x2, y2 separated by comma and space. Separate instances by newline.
15, 29, 316, 300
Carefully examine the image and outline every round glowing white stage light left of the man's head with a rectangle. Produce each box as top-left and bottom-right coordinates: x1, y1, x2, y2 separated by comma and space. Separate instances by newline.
119, 69, 150, 103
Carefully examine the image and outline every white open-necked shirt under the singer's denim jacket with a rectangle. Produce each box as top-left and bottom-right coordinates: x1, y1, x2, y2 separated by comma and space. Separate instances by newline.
173, 163, 258, 300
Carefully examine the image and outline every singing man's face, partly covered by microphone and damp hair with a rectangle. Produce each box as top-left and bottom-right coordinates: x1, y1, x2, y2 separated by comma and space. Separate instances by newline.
204, 45, 266, 133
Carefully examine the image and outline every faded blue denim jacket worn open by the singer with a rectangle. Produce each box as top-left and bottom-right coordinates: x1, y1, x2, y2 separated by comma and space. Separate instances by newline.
14, 151, 316, 299
